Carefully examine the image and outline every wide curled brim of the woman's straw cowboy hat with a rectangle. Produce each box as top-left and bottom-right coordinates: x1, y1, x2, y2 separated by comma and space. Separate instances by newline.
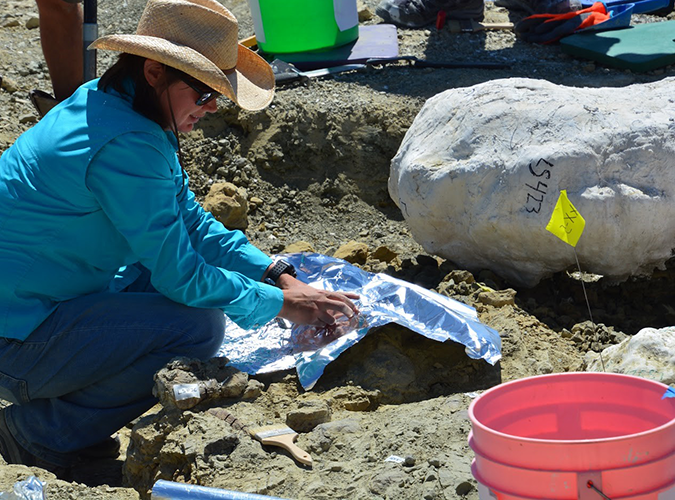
88, 35, 274, 111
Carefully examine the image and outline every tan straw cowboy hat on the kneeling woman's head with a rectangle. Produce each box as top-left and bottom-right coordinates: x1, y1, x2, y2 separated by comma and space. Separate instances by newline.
89, 0, 274, 111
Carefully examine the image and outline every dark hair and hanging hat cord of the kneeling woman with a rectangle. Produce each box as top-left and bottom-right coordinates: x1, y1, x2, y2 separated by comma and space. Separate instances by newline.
98, 52, 188, 195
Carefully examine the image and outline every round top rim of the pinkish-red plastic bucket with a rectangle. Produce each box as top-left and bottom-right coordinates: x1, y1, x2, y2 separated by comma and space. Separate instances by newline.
468, 372, 675, 446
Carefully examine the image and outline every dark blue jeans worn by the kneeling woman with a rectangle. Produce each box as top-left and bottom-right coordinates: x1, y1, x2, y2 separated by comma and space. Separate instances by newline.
0, 271, 224, 466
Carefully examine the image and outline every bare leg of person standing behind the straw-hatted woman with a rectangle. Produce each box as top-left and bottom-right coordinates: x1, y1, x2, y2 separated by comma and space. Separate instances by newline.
36, 0, 83, 101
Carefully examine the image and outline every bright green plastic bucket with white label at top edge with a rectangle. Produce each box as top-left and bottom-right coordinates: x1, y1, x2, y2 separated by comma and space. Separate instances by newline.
248, 0, 359, 54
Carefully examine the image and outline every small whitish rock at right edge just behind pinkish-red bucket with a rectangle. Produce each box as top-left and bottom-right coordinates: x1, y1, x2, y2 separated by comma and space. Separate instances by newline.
586, 326, 675, 385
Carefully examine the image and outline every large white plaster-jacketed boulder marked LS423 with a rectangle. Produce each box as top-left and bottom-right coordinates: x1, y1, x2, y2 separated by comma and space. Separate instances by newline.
389, 78, 675, 285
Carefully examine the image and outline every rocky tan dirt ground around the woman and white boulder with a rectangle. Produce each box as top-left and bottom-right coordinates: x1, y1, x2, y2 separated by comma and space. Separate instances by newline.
0, 0, 675, 500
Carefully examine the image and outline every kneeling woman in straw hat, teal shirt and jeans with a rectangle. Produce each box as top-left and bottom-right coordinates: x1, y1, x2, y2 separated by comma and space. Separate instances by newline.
0, 0, 357, 475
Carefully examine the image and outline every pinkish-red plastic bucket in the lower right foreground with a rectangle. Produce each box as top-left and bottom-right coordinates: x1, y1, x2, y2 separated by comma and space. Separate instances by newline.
469, 373, 675, 500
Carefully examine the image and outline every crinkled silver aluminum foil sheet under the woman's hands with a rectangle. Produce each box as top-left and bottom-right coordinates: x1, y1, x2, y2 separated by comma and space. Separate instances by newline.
219, 253, 501, 390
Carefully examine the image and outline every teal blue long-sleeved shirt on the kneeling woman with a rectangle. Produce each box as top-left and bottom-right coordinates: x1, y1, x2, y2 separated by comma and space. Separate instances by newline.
0, 80, 283, 340
